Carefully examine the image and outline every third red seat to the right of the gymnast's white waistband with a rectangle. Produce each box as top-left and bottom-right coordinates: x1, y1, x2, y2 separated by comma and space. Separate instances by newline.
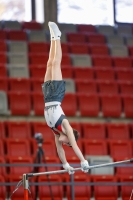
100, 94, 122, 117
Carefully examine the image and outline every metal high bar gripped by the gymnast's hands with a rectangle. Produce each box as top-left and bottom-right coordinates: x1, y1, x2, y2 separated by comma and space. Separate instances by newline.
27, 159, 133, 177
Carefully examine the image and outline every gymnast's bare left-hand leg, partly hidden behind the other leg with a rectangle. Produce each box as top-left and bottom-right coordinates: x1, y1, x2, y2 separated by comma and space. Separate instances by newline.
44, 40, 55, 82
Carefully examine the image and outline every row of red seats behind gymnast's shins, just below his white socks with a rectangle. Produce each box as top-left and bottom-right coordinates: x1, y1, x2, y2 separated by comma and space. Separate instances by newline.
0, 41, 133, 56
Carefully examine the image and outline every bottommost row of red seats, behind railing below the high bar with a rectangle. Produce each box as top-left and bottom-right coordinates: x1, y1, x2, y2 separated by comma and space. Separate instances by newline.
0, 174, 133, 200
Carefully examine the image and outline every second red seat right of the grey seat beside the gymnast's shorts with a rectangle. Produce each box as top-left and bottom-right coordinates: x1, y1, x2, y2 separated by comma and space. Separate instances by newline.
97, 80, 119, 94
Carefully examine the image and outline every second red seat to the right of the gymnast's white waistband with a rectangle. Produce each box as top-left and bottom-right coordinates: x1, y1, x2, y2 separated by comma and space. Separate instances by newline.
78, 94, 100, 117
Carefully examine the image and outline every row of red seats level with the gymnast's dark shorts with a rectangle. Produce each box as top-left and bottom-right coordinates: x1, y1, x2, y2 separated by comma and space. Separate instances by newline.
0, 78, 133, 95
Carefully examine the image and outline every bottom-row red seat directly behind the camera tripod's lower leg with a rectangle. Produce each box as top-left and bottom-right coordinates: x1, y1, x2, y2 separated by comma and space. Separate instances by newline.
38, 175, 63, 200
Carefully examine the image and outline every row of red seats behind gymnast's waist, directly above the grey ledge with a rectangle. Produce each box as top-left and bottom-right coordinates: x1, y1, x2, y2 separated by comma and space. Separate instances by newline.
0, 92, 133, 118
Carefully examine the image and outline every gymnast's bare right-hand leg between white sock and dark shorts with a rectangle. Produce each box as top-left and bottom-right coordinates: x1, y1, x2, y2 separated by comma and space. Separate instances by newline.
52, 40, 62, 80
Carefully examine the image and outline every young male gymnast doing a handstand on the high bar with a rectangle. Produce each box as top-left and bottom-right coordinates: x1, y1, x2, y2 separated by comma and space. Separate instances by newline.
42, 22, 89, 174
